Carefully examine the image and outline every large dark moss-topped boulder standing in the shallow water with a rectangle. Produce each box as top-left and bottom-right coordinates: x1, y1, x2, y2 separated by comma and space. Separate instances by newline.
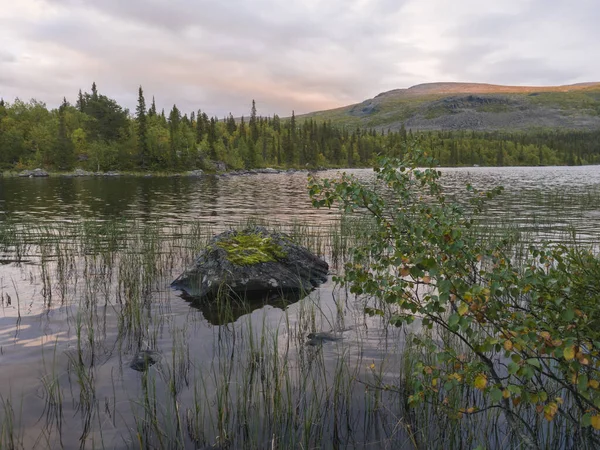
171, 227, 329, 300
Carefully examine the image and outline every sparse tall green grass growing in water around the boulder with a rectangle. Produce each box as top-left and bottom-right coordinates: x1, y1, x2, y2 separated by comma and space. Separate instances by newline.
0, 216, 596, 449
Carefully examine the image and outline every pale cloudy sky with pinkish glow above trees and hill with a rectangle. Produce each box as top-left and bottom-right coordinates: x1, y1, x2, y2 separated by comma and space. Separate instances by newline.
0, 0, 600, 117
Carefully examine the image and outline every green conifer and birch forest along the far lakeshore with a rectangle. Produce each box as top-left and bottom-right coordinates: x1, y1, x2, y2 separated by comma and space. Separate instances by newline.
0, 83, 600, 173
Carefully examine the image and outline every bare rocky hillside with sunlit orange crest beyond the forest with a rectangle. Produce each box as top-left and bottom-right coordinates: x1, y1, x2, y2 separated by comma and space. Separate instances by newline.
300, 82, 600, 131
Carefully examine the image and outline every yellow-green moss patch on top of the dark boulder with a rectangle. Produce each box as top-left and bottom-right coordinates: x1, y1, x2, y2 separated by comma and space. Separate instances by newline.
216, 231, 285, 266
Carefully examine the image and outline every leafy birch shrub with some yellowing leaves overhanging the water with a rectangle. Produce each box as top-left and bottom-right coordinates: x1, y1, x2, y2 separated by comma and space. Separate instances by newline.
309, 149, 600, 447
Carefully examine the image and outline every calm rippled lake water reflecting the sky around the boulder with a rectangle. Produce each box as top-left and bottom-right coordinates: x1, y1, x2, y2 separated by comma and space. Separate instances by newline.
0, 166, 600, 449
